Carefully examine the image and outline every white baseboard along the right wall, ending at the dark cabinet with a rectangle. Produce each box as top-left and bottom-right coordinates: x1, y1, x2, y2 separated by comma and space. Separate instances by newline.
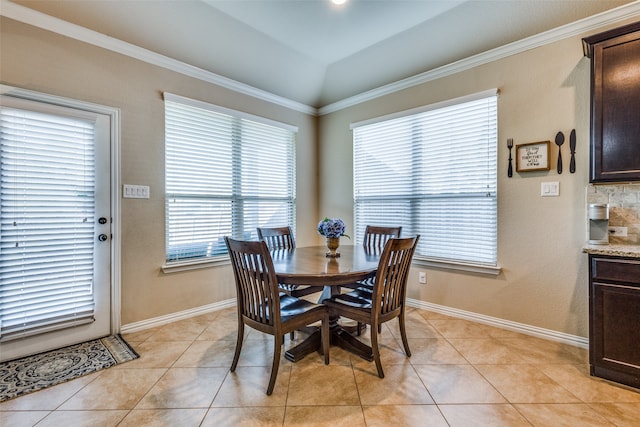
407, 298, 589, 348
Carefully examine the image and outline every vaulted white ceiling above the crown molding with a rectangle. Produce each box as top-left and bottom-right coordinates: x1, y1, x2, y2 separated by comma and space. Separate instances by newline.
7, 0, 633, 108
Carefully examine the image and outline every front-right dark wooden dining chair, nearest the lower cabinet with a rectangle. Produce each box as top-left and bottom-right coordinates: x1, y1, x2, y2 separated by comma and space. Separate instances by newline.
324, 236, 420, 378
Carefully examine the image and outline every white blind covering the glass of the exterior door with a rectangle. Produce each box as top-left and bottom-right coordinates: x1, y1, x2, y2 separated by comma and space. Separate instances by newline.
0, 102, 95, 340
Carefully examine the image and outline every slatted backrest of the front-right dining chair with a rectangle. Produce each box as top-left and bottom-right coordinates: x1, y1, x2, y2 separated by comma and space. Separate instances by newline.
372, 236, 420, 315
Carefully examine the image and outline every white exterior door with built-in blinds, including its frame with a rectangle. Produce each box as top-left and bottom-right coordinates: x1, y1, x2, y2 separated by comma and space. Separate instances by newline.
0, 96, 111, 360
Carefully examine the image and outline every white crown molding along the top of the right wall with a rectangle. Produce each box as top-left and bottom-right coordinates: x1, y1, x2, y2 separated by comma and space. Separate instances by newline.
318, 1, 640, 116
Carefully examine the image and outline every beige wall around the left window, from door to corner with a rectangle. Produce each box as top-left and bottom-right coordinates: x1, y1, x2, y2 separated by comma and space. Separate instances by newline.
0, 18, 317, 325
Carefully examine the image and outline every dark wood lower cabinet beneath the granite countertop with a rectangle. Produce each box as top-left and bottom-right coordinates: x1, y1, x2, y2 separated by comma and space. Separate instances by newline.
589, 255, 640, 388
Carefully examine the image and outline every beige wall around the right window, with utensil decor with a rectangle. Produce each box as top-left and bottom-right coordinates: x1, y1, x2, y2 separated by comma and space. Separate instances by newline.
319, 20, 636, 337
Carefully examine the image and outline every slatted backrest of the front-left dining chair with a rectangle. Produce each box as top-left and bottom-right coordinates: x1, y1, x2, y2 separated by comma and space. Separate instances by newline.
225, 237, 280, 326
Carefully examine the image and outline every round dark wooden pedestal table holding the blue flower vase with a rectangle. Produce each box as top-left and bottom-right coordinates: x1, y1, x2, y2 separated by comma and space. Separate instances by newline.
271, 245, 380, 362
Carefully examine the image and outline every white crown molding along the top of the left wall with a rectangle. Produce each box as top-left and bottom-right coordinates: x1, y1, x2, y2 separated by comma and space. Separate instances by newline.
0, 0, 317, 116
